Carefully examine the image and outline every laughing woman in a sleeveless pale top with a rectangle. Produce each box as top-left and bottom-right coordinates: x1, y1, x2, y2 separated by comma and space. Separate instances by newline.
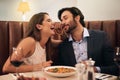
3, 12, 55, 73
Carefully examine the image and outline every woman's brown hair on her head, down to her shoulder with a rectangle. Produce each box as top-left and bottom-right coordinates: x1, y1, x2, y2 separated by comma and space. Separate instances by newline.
25, 12, 48, 41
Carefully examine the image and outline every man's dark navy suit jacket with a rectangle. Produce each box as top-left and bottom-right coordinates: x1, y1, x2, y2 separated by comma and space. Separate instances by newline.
55, 30, 118, 75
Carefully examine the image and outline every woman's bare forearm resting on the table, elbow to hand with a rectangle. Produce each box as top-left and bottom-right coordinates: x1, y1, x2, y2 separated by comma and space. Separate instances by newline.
3, 58, 52, 73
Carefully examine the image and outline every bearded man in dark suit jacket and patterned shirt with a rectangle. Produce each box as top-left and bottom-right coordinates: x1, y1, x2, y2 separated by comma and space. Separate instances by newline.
57, 7, 118, 75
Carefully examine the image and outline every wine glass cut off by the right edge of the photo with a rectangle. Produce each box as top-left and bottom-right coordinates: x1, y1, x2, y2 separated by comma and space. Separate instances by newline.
114, 47, 120, 80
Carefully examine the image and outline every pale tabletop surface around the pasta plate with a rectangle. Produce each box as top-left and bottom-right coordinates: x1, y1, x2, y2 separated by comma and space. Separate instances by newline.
0, 71, 116, 80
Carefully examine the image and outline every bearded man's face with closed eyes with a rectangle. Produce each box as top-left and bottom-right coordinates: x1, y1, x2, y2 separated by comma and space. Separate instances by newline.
61, 11, 76, 33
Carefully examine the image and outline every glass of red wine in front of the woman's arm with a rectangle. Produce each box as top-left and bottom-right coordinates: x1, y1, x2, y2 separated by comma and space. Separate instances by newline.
10, 47, 23, 76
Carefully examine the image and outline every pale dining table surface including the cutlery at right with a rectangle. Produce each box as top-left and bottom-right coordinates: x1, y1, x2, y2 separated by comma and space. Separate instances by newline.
0, 71, 117, 80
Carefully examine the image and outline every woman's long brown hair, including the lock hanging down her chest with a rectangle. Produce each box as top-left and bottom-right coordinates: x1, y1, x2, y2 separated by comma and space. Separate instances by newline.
25, 12, 53, 60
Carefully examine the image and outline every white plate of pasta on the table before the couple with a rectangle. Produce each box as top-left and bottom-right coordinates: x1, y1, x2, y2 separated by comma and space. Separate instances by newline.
44, 66, 76, 77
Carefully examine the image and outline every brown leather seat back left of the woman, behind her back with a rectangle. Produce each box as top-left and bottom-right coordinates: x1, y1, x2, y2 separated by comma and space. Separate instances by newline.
0, 21, 27, 75
